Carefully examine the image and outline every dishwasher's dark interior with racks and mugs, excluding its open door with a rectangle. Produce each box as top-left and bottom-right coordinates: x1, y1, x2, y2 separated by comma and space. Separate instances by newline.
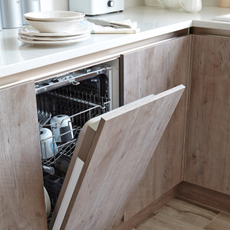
35, 59, 119, 225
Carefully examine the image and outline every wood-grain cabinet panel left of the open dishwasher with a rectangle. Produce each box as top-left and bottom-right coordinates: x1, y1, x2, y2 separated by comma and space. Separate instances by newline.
0, 82, 47, 230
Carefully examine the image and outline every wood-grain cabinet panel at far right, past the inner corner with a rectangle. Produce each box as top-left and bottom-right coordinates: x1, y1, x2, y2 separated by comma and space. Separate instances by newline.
185, 35, 230, 195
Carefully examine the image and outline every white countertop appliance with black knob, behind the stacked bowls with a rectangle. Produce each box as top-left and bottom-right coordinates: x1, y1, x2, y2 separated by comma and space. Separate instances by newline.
69, 0, 124, 16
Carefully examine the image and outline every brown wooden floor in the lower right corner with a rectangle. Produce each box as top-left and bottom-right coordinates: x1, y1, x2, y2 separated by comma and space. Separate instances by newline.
133, 198, 230, 230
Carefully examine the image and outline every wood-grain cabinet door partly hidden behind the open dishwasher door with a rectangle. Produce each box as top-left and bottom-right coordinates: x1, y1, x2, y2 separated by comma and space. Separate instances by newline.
121, 36, 191, 220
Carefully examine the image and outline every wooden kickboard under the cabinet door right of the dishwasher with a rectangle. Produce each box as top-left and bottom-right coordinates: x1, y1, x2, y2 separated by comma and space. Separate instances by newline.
113, 186, 177, 230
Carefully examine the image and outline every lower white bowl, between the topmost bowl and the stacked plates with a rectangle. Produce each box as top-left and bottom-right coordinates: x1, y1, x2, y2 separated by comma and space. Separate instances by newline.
25, 18, 83, 33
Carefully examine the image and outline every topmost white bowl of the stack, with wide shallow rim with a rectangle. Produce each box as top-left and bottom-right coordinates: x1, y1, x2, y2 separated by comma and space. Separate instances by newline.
24, 11, 85, 22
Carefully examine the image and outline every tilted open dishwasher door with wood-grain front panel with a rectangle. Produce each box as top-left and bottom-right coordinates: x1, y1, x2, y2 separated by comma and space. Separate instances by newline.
50, 85, 185, 230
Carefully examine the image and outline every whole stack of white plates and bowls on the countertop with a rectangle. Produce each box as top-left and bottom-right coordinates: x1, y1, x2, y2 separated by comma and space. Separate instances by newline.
18, 11, 90, 45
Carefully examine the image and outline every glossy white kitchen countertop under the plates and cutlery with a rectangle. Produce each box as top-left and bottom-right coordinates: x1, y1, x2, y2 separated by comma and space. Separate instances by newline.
0, 6, 230, 78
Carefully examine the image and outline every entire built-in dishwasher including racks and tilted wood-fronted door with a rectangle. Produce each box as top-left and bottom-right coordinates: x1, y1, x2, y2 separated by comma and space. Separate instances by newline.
32, 56, 185, 230
